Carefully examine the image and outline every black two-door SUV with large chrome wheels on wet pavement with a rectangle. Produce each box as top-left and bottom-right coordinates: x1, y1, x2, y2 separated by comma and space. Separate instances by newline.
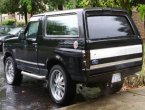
3, 8, 143, 104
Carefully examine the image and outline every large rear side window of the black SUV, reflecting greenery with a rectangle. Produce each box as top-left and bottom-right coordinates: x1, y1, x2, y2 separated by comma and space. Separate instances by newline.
46, 15, 78, 36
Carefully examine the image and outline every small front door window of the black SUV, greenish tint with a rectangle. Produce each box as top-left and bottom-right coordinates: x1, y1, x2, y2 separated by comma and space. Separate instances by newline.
25, 21, 39, 38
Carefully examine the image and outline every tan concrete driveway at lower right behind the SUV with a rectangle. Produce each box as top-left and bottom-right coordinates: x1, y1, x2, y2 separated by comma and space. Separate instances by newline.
59, 87, 145, 110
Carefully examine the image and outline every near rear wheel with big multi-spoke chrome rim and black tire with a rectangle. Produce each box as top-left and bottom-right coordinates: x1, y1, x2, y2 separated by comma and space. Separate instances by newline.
48, 65, 76, 105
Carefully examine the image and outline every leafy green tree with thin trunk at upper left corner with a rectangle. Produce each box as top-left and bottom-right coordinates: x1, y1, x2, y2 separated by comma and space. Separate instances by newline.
0, 0, 47, 23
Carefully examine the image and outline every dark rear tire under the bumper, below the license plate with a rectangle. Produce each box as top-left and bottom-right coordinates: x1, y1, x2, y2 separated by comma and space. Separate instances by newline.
100, 81, 124, 96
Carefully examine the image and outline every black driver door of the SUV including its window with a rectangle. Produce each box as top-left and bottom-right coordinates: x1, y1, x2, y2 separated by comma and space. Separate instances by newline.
17, 17, 40, 74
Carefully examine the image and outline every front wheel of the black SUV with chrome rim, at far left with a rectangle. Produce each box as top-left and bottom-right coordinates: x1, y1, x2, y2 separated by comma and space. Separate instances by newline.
4, 57, 23, 86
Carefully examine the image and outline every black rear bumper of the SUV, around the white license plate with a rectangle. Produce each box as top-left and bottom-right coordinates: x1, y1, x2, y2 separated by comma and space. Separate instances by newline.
71, 65, 142, 85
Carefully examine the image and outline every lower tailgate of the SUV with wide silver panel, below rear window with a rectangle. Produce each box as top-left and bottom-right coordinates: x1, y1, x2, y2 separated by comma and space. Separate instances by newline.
88, 39, 143, 75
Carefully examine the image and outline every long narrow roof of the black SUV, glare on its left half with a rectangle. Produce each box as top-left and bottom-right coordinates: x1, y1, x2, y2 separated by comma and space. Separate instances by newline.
33, 7, 128, 17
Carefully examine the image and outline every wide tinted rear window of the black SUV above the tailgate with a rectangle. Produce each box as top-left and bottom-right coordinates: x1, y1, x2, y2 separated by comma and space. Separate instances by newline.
87, 16, 134, 39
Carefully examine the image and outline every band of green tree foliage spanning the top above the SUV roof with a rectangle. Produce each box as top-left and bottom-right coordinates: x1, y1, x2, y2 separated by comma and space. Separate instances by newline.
0, 0, 145, 23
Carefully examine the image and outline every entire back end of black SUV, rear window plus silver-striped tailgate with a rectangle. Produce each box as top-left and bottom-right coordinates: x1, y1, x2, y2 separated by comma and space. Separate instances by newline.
85, 10, 143, 75
